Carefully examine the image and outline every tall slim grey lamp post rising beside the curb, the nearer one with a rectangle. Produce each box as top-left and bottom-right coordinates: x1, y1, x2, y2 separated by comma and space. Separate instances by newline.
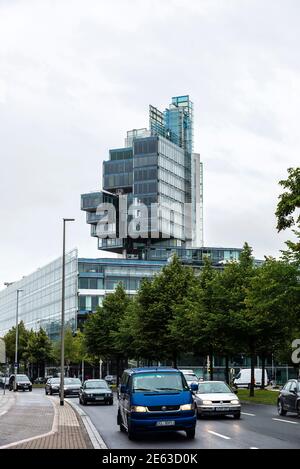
60, 218, 75, 405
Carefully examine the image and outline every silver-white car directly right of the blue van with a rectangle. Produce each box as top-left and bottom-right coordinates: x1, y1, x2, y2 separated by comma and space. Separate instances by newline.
195, 381, 241, 419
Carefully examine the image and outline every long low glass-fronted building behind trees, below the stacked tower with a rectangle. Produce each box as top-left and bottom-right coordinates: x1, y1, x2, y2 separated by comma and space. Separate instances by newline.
0, 248, 240, 339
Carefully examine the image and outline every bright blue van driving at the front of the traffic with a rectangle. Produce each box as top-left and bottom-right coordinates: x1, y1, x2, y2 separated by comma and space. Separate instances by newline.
117, 367, 198, 439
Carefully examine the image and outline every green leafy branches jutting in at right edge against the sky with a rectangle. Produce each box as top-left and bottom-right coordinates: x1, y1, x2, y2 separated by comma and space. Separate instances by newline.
275, 168, 300, 265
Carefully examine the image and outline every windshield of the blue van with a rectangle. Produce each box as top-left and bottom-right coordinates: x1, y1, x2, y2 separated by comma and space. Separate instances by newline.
132, 372, 188, 393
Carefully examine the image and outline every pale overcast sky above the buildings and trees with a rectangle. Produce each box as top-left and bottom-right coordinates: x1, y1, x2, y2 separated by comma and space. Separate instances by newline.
0, 0, 300, 288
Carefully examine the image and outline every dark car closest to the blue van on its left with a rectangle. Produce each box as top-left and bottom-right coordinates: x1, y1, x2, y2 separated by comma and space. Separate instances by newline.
79, 379, 114, 405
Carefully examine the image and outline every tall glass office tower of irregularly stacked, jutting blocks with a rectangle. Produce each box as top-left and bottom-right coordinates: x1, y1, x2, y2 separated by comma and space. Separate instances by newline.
81, 95, 203, 258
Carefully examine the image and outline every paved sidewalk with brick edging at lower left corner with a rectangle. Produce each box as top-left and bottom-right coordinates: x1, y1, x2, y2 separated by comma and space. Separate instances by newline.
0, 393, 94, 449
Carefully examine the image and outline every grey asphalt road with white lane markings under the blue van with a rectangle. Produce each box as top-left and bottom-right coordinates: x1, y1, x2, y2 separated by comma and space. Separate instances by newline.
73, 397, 300, 449
